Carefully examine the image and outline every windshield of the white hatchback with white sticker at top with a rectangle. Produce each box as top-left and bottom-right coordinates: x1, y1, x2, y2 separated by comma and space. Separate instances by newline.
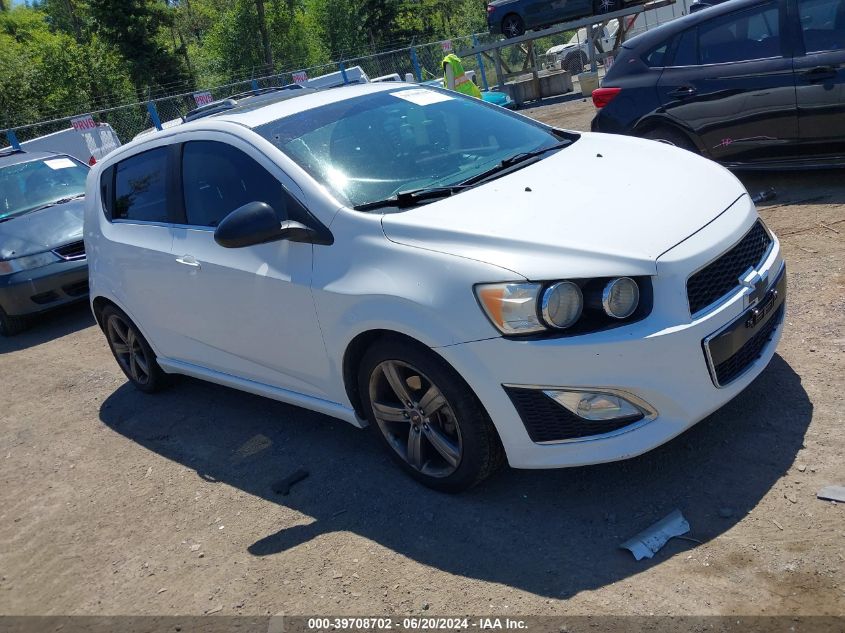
255, 88, 572, 206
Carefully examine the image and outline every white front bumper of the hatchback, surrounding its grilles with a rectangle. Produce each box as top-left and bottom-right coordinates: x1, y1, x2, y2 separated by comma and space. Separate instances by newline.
438, 204, 785, 468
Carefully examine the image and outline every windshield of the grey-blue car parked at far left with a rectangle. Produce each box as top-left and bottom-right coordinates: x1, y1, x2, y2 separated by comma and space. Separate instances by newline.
0, 156, 88, 220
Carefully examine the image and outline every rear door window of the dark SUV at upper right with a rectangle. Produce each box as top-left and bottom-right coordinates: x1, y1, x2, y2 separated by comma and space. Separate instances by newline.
698, 2, 781, 64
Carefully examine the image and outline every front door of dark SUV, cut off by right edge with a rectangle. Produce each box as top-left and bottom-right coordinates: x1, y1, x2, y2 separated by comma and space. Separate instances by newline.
793, 0, 845, 157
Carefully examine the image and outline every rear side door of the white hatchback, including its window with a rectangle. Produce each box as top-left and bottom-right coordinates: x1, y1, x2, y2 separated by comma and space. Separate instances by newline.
101, 145, 177, 351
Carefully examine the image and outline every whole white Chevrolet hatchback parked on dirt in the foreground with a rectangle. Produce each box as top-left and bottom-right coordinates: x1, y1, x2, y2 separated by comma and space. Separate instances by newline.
85, 83, 786, 491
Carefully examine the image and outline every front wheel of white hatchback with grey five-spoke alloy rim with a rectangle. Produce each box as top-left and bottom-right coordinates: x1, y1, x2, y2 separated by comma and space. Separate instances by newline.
358, 338, 504, 492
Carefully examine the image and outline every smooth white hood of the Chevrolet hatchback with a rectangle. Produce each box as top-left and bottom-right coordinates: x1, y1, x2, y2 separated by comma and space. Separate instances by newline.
382, 134, 746, 280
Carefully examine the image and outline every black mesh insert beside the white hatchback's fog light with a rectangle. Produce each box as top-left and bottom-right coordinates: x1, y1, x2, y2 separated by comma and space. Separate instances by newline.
505, 387, 643, 442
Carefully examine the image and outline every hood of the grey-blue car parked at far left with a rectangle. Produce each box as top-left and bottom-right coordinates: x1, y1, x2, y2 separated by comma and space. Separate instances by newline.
0, 198, 85, 259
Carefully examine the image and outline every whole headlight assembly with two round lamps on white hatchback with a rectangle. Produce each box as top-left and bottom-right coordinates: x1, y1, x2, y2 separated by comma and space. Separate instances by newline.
475, 277, 652, 336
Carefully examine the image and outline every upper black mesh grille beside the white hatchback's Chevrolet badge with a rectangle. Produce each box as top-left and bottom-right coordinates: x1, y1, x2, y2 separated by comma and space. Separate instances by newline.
687, 220, 772, 314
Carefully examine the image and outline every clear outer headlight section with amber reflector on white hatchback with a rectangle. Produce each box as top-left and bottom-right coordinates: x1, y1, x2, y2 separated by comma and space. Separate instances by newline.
475, 283, 546, 334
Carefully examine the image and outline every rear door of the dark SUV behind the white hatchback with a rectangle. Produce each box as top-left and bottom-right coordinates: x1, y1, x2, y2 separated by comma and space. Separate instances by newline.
658, 0, 798, 162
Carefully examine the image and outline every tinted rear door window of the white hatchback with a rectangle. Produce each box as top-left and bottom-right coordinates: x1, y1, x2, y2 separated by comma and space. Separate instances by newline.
112, 147, 169, 222
